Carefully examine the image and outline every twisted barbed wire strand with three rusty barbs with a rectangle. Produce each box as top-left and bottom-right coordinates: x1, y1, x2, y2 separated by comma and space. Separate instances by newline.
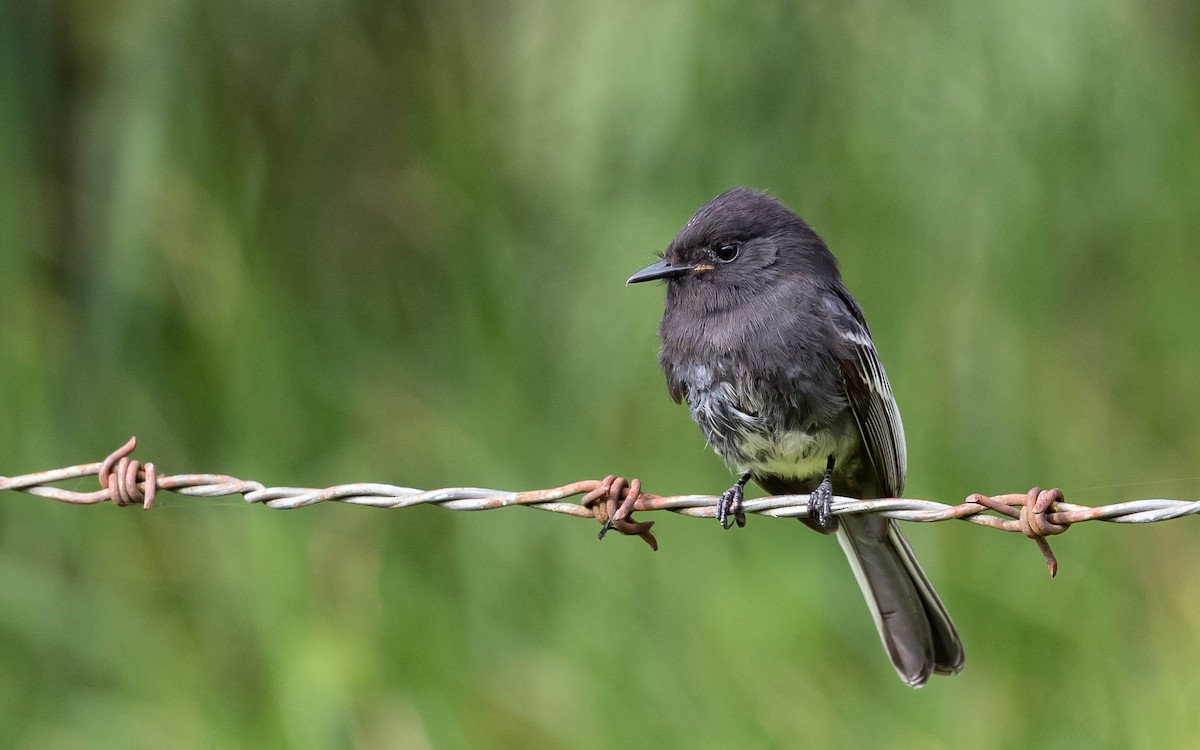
7, 438, 1200, 576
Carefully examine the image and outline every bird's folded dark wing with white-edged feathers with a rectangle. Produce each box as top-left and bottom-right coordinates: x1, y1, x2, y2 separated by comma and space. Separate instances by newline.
824, 286, 907, 497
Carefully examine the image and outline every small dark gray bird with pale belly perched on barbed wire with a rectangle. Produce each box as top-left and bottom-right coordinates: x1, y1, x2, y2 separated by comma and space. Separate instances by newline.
629, 187, 964, 688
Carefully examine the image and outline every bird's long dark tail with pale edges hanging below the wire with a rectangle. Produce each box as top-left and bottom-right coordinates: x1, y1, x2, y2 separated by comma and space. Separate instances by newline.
838, 515, 962, 688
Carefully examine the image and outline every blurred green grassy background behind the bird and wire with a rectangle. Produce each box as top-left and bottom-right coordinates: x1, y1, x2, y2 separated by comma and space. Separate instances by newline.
0, 0, 1200, 749
